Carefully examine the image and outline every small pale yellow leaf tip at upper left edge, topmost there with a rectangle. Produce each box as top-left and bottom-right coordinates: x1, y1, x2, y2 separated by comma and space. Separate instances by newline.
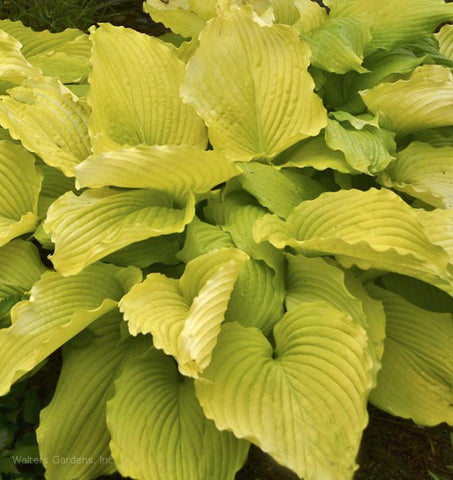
0, 29, 41, 84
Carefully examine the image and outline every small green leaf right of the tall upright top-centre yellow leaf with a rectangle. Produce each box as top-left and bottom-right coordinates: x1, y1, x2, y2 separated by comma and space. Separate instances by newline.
302, 17, 371, 73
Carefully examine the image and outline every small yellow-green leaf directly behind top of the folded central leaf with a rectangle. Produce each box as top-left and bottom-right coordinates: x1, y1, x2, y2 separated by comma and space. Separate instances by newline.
177, 217, 234, 263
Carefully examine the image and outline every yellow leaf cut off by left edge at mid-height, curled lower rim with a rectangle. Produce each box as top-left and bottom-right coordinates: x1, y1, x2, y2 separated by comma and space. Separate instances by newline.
0, 140, 42, 246
